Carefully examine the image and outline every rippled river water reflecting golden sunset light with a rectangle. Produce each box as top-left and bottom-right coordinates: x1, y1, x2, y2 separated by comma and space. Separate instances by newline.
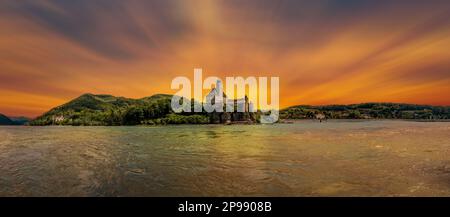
0, 121, 450, 196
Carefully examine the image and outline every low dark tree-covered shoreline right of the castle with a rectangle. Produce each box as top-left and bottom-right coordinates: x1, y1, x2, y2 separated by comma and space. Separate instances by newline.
280, 103, 450, 120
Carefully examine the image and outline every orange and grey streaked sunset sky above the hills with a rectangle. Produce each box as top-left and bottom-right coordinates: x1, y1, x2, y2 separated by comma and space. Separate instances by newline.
0, 0, 450, 117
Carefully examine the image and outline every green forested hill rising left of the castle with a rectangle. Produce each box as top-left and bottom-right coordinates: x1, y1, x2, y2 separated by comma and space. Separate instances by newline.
30, 94, 209, 126
